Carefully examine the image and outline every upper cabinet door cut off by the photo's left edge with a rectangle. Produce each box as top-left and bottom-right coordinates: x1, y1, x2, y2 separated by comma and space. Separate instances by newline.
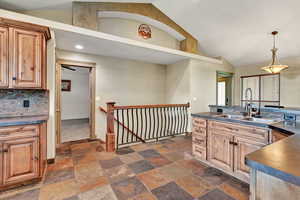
0, 27, 8, 88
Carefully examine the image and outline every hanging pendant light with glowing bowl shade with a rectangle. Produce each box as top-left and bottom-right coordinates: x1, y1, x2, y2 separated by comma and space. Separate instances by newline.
261, 31, 288, 74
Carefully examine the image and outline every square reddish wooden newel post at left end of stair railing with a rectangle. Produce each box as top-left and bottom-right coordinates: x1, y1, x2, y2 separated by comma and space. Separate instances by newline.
106, 102, 116, 152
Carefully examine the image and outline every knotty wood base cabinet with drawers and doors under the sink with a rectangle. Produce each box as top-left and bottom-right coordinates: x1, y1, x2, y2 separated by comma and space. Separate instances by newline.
193, 118, 270, 182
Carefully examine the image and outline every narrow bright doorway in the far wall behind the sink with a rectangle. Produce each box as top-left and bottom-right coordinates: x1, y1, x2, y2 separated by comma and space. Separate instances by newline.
216, 71, 233, 106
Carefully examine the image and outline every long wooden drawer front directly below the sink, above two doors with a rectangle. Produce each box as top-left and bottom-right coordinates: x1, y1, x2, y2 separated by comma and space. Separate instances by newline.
208, 121, 269, 143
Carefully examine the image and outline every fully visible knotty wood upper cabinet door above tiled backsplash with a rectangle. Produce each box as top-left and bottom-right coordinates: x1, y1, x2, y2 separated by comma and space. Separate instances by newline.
9, 28, 44, 88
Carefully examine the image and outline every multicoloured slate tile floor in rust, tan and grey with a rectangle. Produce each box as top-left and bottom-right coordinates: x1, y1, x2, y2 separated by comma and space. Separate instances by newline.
0, 136, 249, 200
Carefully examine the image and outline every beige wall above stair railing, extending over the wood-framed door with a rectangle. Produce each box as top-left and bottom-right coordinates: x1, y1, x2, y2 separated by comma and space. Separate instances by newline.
57, 50, 166, 140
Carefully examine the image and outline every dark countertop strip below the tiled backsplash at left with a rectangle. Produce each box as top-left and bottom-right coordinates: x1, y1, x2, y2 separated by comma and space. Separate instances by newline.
0, 115, 48, 127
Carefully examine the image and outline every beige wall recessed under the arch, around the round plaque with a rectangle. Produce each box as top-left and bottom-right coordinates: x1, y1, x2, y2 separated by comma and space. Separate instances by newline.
98, 18, 180, 49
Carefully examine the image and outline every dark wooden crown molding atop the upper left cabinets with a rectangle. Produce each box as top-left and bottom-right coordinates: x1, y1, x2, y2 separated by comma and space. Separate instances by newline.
0, 17, 51, 40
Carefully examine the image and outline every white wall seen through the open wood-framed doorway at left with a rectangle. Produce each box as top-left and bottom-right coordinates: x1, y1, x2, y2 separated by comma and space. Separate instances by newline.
61, 67, 90, 120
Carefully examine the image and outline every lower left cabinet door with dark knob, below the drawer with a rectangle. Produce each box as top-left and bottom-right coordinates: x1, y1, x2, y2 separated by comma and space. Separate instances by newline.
3, 137, 39, 185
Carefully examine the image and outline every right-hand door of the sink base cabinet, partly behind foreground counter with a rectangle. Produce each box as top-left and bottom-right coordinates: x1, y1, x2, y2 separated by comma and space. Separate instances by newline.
234, 137, 266, 179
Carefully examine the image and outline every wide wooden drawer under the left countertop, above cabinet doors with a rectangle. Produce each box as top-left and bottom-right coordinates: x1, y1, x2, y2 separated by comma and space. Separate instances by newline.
0, 125, 39, 140
